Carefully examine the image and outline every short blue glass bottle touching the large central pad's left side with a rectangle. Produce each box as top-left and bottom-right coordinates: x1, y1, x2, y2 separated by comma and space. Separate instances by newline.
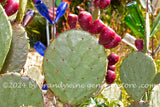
34, 41, 46, 56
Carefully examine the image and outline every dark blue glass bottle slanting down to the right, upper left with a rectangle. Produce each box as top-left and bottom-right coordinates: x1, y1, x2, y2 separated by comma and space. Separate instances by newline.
35, 0, 53, 24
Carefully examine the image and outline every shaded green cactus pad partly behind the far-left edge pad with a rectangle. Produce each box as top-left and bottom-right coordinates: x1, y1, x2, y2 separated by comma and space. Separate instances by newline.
2, 24, 29, 72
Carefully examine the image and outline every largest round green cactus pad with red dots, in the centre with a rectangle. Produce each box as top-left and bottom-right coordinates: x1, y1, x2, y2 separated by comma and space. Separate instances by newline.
43, 30, 107, 105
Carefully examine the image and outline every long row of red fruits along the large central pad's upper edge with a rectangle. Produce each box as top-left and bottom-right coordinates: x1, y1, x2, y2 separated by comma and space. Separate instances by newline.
67, 11, 121, 49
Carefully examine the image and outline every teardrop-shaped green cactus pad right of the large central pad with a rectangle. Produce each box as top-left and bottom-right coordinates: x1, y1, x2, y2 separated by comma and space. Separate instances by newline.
120, 52, 156, 101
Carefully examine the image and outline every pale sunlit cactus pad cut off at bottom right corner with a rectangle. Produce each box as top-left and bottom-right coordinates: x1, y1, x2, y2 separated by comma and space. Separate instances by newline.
149, 84, 160, 107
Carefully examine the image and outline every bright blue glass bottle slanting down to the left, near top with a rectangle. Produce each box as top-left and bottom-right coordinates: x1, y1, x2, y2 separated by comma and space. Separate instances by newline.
54, 1, 68, 23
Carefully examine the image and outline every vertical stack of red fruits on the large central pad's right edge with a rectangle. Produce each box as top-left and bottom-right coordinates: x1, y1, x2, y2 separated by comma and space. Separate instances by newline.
105, 53, 119, 84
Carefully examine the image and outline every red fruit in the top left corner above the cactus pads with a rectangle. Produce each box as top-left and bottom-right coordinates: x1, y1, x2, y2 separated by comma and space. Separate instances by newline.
0, 0, 19, 16
